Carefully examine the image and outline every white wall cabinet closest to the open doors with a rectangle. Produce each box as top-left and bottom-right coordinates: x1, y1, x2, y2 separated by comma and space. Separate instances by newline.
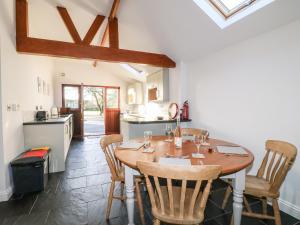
127, 82, 144, 105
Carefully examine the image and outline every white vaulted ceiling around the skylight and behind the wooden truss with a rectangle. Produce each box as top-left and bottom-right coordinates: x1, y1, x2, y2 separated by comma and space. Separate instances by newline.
28, 0, 300, 76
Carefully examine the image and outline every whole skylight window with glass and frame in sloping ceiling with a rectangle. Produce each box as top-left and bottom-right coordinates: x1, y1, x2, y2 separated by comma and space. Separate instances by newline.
209, 0, 256, 19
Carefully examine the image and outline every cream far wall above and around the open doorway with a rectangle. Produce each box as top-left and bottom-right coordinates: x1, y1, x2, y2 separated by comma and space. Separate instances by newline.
55, 59, 128, 110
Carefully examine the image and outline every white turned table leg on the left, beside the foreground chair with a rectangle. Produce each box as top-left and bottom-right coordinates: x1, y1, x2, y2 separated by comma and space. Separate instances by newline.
125, 166, 134, 225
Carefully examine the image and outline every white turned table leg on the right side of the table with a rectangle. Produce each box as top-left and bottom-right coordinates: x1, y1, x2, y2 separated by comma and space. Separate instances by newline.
233, 169, 246, 225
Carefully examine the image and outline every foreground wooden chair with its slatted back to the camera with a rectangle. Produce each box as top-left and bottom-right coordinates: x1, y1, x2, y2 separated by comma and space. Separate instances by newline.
137, 162, 221, 225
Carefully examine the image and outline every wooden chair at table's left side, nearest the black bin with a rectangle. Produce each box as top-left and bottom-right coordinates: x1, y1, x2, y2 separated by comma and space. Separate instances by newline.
100, 134, 145, 225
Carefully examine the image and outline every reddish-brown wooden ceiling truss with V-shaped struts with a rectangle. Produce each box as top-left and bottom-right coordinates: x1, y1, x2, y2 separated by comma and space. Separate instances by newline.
16, 0, 176, 68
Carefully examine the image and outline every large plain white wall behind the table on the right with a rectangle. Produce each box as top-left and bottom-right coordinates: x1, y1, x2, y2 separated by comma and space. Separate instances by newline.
186, 21, 300, 218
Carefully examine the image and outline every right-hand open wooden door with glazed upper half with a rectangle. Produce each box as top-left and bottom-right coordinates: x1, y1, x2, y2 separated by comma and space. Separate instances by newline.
104, 87, 120, 134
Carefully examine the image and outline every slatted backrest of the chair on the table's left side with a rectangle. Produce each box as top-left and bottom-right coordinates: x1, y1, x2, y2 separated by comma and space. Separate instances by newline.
100, 134, 123, 178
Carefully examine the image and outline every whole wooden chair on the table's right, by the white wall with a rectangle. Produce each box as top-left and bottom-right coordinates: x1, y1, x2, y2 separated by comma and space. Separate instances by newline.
222, 140, 297, 225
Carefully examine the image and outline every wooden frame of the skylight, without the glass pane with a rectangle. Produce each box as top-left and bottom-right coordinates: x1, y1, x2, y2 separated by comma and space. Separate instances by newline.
208, 0, 257, 19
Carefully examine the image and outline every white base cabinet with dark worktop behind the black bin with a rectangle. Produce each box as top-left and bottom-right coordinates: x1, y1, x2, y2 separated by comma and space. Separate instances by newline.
23, 115, 73, 173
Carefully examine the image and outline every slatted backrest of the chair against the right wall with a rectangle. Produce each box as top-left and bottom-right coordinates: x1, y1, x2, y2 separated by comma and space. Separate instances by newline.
257, 140, 297, 193
